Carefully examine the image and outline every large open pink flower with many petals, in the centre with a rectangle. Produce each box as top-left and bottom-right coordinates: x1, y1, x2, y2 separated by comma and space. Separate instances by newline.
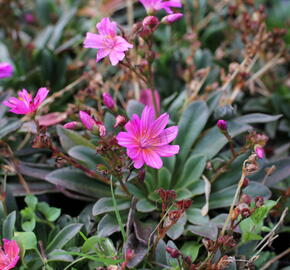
116, 106, 179, 169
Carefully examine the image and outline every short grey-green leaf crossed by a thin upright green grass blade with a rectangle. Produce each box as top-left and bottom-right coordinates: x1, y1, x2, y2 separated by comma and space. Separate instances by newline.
93, 198, 130, 216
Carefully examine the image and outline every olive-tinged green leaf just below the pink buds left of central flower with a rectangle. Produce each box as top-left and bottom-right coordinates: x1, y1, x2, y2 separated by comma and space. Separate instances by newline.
57, 125, 95, 152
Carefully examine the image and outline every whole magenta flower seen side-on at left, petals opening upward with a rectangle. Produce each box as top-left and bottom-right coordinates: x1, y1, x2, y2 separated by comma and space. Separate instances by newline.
3, 87, 49, 114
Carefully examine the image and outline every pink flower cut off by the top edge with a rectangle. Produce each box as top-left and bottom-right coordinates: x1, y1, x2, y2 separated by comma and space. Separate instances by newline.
139, 0, 182, 14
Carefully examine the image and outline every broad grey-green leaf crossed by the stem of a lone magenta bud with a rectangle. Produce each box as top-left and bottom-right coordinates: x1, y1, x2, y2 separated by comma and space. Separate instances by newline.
191, 121, 252, 159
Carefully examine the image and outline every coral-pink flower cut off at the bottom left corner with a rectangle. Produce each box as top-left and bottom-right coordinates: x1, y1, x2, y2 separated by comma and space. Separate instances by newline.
0, 239, 20, 270
